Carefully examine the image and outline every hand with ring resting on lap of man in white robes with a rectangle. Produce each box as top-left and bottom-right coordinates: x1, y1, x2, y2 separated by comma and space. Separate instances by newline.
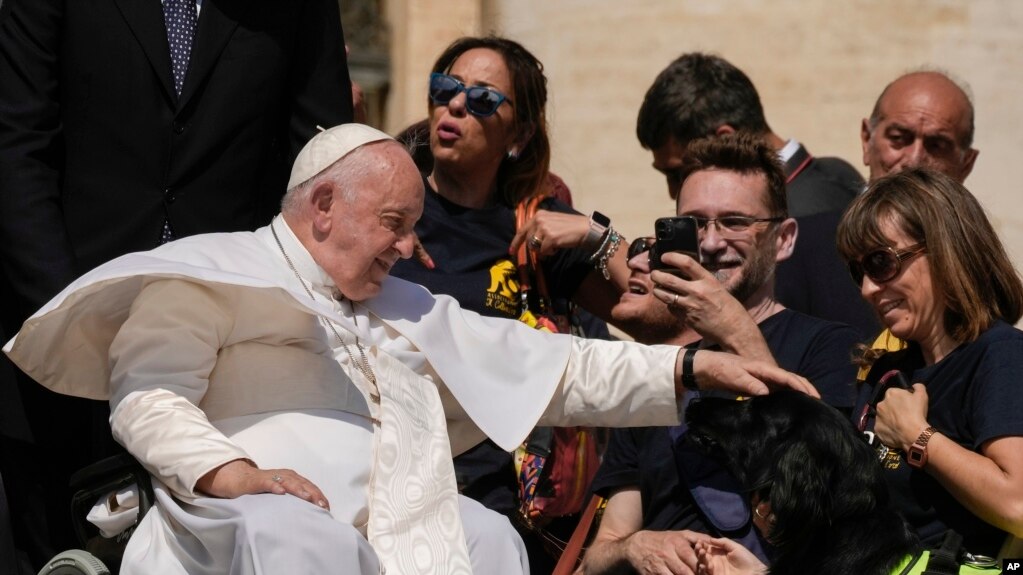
195, 459, 330, 510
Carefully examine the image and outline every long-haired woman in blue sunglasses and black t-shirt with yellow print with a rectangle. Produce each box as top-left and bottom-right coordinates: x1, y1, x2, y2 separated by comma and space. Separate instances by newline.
392, 37, 628, 573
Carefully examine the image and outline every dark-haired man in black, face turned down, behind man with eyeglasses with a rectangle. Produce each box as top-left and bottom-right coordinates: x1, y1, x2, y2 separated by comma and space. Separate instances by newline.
636, 52, 878, 339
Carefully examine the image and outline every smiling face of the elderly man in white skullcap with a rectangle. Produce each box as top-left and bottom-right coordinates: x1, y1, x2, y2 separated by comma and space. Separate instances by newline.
313, 141, 424, 301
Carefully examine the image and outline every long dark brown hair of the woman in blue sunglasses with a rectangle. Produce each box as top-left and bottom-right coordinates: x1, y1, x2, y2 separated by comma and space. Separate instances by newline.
431, 36, 550, 206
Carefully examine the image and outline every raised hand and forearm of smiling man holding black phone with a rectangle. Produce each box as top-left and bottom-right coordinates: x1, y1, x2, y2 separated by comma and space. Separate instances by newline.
650, 253, 774, 363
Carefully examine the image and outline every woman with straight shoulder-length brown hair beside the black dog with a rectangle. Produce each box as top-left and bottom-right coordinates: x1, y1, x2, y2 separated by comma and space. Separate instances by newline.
838, 169, 1023, 557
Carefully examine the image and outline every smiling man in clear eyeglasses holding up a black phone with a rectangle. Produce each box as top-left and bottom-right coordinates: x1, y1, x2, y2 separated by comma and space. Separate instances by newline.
583, 133, 857, 574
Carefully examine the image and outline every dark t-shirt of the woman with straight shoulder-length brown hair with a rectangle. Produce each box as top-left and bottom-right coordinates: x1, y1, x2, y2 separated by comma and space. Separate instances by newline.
853, 321, 1023, 557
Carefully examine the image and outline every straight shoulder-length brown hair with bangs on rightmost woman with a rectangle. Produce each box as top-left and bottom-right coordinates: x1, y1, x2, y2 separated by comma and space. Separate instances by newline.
837, 168, 1023, 343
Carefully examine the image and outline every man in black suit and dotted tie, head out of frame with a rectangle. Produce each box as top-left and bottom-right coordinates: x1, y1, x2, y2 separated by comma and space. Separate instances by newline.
0, 0, 352, 555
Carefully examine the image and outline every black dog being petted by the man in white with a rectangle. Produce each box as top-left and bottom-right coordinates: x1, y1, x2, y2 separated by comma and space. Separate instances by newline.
685, 391, 919, 575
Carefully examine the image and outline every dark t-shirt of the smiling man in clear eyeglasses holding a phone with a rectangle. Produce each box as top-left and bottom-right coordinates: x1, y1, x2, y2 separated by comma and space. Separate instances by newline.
593, 310, 858, 533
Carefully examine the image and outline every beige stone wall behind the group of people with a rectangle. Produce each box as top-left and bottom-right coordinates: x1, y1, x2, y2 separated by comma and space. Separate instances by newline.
385, 0, 1023, 267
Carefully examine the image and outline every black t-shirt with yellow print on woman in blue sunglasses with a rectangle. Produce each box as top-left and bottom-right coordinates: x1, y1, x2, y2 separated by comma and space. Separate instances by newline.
391, 183, 593, 513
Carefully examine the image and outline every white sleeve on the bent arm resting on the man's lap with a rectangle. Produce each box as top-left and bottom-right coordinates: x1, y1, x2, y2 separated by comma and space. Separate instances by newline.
110, 279, 248, 497
